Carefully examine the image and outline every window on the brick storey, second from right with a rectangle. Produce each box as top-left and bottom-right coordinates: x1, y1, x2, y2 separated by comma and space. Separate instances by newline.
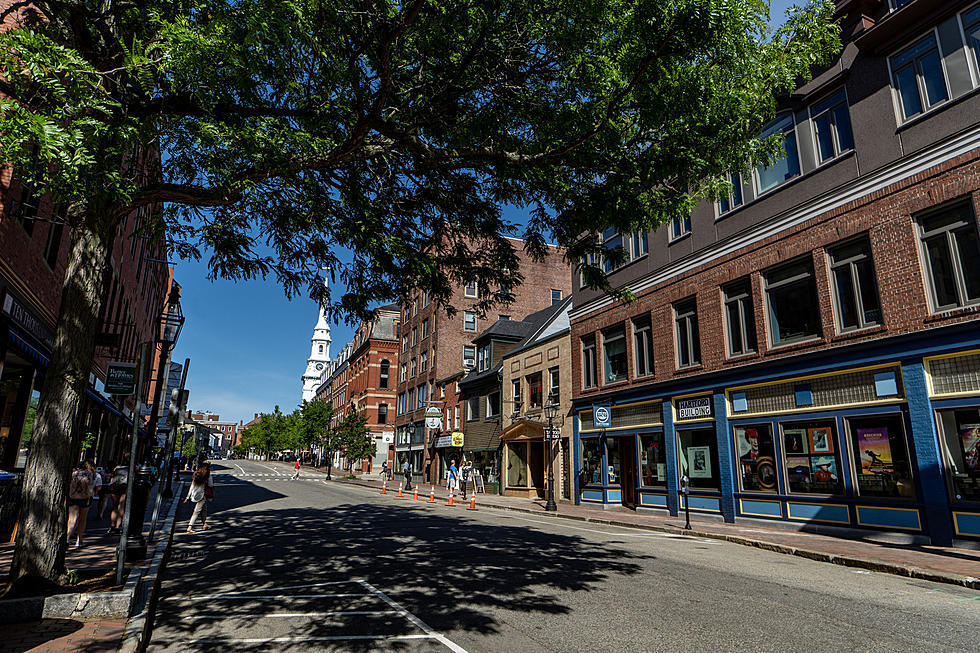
827, 238, 881, 331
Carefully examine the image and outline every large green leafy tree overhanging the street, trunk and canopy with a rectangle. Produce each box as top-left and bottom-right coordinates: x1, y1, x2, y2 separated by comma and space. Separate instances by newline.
0, 0, 840, 580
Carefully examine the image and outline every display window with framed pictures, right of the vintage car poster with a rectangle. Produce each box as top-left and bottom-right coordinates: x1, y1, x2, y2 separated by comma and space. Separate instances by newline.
780, 420, 844, 494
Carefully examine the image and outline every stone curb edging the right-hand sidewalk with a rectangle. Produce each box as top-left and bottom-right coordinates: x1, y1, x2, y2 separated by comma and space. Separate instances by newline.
344, 481, 980, 590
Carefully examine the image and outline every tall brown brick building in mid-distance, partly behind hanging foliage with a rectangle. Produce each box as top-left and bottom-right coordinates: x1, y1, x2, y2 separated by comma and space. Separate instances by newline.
395, 241, 571, 482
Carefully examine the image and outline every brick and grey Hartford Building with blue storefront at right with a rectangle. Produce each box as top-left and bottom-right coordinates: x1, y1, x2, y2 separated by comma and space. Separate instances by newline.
571, 0, 980, 543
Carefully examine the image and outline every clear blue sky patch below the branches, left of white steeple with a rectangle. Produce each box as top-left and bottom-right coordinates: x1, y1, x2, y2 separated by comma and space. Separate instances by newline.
173, 0, 792, 422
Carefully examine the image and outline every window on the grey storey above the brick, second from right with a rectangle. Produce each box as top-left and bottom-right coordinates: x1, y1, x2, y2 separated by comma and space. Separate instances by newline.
889, 35, 949, 120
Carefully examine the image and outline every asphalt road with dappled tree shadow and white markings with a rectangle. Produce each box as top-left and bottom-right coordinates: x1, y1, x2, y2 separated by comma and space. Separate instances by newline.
149, 461, 980, 652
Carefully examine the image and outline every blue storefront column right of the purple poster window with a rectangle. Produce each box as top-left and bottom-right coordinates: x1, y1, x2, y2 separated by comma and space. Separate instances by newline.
902, 360, 953, 546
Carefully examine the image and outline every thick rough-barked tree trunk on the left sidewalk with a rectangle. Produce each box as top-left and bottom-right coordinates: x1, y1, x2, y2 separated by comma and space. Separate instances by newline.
11, 216, 115, 582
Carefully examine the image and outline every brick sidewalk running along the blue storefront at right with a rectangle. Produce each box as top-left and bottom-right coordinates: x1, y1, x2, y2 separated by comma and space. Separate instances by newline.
338, 468, 980, 589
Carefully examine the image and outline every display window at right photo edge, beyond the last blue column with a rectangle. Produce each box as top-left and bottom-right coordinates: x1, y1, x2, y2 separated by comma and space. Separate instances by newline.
937, 408, 980, 502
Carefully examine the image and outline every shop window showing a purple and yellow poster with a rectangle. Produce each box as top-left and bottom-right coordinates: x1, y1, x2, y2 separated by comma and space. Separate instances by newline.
847, 415, 915, 499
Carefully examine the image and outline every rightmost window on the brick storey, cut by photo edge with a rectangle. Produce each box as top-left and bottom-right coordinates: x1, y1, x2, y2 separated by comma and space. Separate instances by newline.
919, 204, 980, 311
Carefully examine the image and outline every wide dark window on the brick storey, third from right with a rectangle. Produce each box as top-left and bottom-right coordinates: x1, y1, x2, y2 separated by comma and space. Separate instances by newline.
763, 260, 820, 345
